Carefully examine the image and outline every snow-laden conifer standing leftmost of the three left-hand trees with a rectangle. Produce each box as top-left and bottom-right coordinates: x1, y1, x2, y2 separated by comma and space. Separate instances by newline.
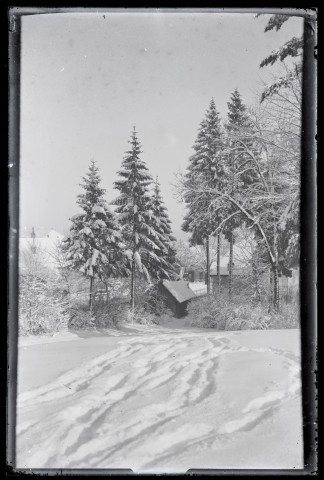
63, 160, 127, 311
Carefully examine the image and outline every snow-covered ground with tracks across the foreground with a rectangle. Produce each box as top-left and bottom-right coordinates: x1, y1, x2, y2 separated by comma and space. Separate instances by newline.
17, 319, 303, 472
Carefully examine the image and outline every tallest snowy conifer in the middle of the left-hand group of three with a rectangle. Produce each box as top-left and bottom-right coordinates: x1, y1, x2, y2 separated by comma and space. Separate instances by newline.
112, 127, 160, 310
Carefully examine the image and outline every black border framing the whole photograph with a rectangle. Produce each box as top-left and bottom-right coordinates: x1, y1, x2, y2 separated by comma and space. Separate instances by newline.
7, 7, 317, 477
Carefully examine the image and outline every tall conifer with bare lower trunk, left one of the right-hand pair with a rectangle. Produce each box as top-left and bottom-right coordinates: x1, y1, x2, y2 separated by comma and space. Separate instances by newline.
182, 99, 224, 293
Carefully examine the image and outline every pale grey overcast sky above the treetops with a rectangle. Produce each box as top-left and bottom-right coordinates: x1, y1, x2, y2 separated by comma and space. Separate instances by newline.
20, 11, 302, 238
